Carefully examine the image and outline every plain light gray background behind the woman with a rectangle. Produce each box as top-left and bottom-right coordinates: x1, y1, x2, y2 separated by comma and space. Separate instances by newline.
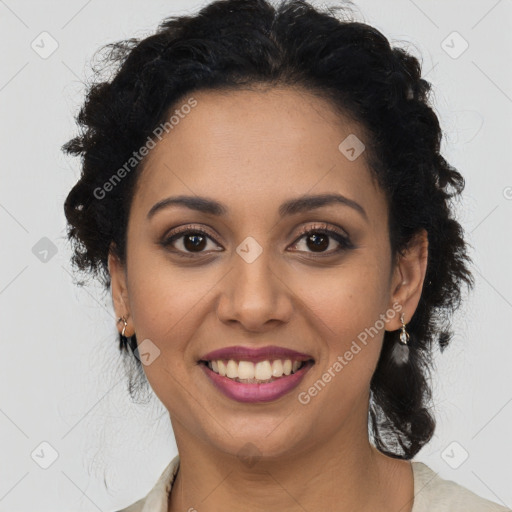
0, 0, 512, 512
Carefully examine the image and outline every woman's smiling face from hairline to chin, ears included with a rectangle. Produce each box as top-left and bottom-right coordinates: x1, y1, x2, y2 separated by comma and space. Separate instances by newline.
109, 88, 424, 456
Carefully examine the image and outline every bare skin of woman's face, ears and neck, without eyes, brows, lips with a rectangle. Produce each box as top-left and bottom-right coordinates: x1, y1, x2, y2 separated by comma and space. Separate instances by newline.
109, 88, 428, 512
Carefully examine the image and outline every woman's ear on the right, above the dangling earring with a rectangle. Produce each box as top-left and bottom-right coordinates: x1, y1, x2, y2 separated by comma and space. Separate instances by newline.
386, 229, 428, 331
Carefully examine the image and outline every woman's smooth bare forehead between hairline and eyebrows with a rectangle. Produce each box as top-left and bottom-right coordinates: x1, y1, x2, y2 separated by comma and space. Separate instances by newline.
133, 88, 382, 222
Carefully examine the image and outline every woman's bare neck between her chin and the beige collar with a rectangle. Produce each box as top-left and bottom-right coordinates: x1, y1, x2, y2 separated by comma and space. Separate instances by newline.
169, 414, 413, 512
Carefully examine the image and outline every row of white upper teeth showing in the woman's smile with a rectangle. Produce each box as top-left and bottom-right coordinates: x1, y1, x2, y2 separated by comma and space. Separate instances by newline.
208, 359, 302, 381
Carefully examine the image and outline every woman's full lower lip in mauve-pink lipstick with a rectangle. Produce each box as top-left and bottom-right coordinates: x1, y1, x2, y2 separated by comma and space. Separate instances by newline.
200, 361, 314, 402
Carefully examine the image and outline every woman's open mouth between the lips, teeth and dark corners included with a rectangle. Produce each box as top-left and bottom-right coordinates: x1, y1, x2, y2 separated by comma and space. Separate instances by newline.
199, 358, 314, 384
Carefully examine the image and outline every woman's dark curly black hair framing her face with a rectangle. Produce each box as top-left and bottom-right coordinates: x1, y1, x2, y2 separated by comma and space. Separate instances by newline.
63, 0, 474, 459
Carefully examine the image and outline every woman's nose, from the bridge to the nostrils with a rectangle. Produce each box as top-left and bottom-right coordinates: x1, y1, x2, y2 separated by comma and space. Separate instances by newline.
216, 251, 294, 332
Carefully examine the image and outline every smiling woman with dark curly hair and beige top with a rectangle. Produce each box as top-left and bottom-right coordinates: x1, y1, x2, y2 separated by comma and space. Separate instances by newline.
64, 0, 507, 512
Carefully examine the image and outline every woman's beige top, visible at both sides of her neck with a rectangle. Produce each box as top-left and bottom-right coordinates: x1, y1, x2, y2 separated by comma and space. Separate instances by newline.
114, 455, 512, 512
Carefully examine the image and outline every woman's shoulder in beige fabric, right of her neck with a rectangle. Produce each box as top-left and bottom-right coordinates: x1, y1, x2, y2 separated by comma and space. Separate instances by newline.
411, 461, 511, 512
